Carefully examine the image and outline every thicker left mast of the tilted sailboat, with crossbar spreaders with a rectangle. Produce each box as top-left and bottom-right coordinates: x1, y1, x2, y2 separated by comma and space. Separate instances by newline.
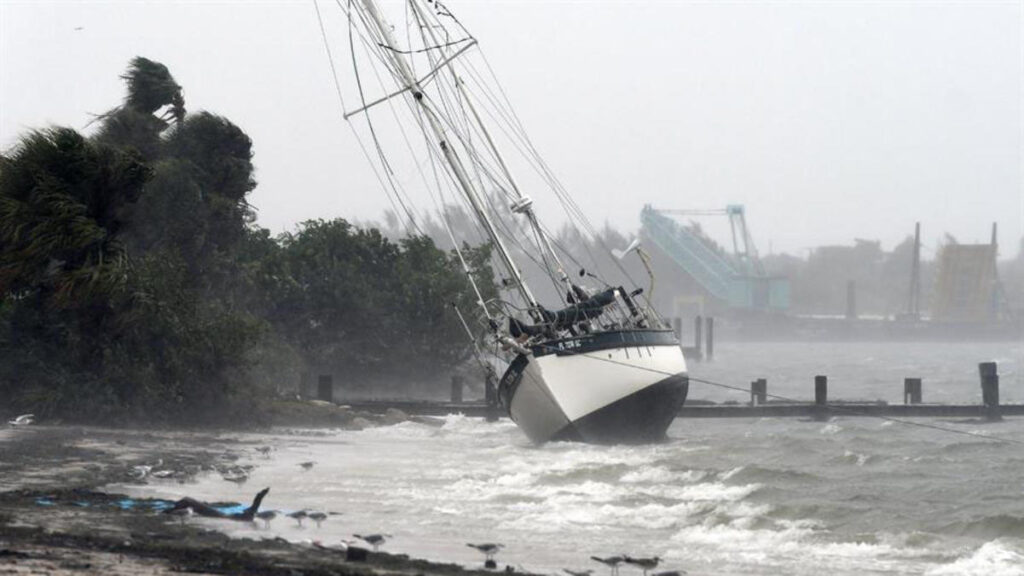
362, 0, 540, 318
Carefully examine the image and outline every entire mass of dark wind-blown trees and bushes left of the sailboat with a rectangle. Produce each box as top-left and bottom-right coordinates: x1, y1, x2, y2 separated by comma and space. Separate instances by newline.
0, 57, 497, 422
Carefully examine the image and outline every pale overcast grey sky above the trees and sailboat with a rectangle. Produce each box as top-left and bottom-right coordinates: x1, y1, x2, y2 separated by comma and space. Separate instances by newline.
0, 0, 1024, 257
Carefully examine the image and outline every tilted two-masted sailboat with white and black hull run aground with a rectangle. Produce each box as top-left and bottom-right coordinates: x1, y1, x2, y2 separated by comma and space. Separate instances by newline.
329, 0, 689, 444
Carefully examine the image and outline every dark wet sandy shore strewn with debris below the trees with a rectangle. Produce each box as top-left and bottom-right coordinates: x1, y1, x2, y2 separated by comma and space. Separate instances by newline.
0, 425, 520, 576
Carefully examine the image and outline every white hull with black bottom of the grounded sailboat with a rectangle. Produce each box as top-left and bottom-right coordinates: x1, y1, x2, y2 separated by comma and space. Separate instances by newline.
502, 330, 688, 444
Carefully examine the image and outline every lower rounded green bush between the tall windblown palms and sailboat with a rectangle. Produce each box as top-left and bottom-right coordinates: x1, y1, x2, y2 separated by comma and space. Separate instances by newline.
267, 219, 496, 379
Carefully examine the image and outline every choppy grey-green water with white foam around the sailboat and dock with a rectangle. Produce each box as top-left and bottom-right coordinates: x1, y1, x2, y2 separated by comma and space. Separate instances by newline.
114, 344, 1024, 576
